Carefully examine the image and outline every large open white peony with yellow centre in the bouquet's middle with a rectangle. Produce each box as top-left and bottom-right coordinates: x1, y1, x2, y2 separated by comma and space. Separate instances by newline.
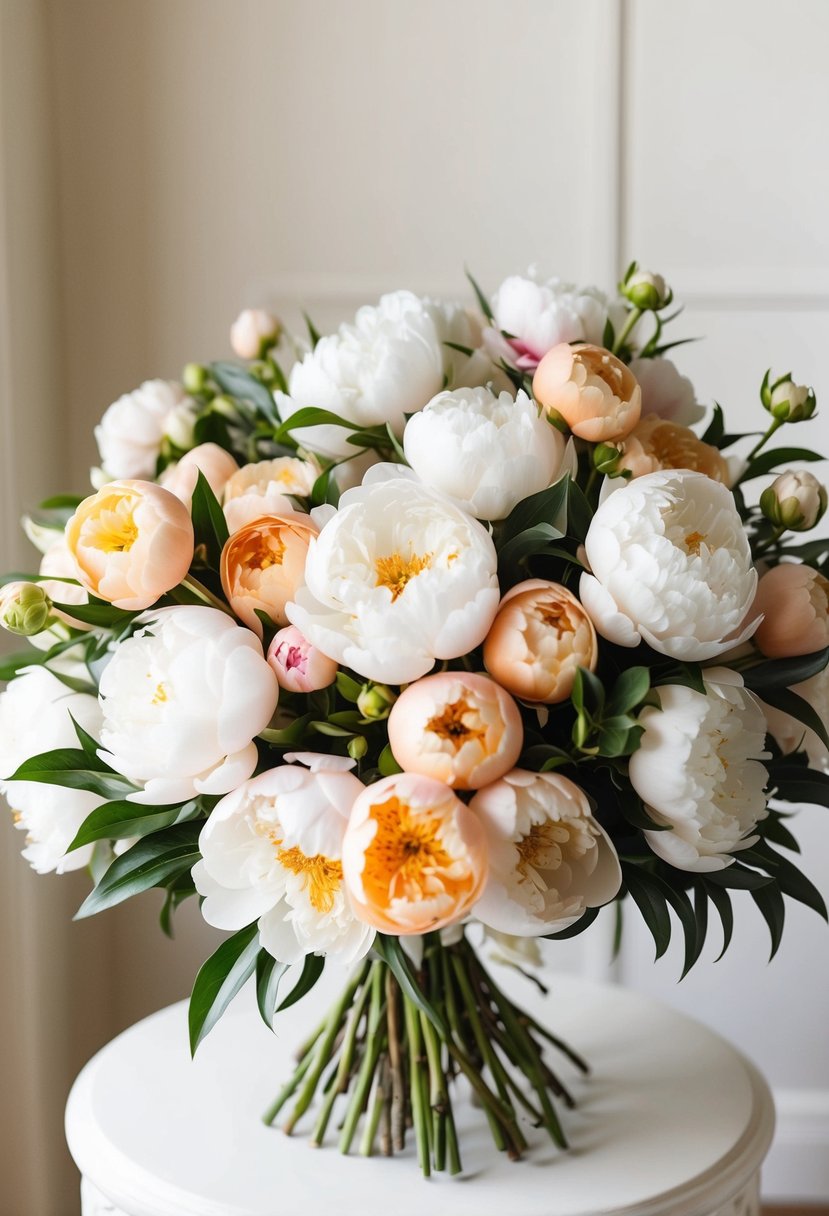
286, 478, 498, 683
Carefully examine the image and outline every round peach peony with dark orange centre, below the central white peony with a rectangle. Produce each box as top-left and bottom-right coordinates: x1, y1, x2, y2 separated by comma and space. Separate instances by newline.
389, 671, 515, 789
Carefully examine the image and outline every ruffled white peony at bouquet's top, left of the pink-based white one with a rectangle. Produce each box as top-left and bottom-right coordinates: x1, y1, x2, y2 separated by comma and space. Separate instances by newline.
276, 292, 444, 457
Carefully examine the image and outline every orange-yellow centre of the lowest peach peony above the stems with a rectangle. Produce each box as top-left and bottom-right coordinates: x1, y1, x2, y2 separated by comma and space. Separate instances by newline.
362, 798, 454, 906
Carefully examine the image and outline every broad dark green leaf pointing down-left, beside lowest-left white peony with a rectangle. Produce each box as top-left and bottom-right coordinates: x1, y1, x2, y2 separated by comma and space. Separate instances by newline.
75, 823, 201, 921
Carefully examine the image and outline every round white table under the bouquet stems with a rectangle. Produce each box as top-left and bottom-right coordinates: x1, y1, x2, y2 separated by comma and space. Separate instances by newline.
66, 968, 774, 1216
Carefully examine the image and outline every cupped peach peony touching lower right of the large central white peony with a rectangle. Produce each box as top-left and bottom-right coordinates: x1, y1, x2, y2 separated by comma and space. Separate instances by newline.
484, 579, 598, 705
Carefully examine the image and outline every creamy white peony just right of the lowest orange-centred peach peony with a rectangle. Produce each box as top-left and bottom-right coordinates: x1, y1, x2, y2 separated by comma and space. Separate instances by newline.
469, 769, 621, 936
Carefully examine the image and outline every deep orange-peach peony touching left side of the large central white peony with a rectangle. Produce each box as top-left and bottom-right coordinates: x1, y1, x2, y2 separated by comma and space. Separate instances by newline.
221, 512, 317, 637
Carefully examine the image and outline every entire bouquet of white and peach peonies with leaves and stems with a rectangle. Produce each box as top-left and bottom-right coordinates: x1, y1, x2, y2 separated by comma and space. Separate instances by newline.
0, 264, 829, 1173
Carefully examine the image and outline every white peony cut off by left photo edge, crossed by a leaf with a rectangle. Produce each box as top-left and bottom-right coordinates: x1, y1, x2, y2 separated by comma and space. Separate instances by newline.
0, 666, 102, 874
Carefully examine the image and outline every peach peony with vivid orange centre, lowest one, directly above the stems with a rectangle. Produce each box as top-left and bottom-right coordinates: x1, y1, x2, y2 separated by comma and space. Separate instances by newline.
343, 773, 487, 936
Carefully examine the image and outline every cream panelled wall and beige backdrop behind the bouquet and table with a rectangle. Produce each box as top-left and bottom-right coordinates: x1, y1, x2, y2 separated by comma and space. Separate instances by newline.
0, 0, 829, 1216
